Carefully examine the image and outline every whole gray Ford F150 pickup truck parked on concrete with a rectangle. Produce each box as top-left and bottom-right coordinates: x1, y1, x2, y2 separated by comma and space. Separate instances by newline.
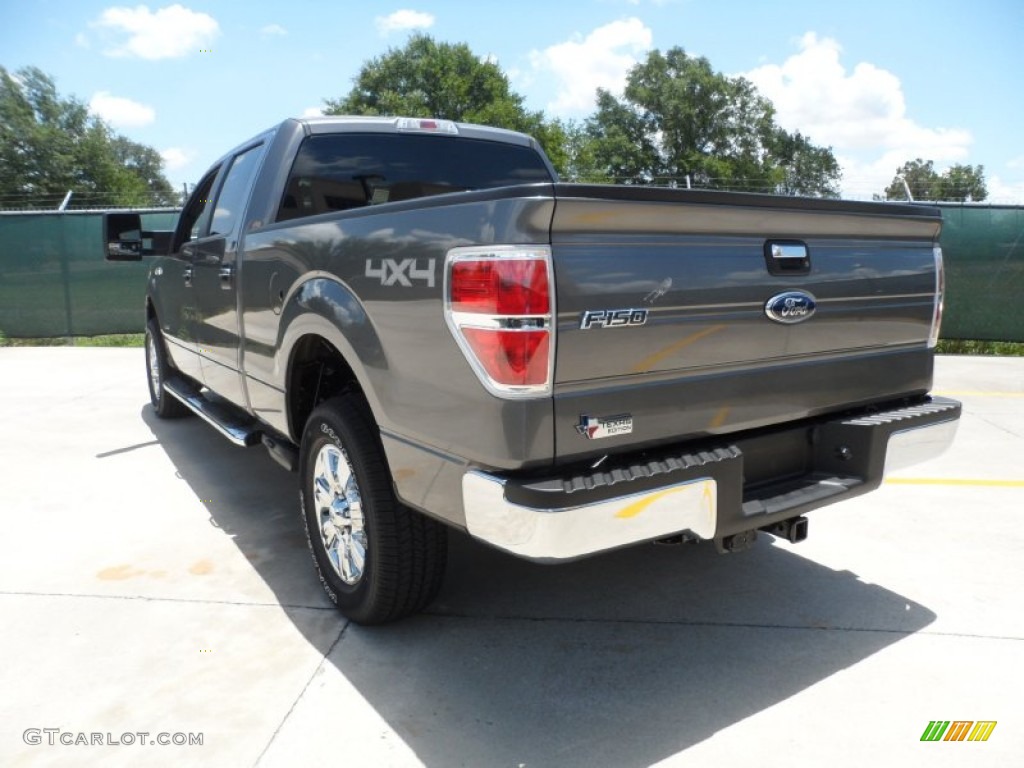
104, 118, 961, 624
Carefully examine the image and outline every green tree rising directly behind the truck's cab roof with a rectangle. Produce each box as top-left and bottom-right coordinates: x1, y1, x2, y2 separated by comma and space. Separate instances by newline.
325, 35, 567, 172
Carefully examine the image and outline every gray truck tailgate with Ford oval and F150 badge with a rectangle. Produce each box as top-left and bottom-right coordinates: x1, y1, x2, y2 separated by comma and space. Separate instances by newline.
551, 184, 941, 460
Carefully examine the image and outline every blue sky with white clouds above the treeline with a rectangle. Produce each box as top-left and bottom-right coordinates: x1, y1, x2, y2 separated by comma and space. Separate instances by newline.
0, 0, 1024, 203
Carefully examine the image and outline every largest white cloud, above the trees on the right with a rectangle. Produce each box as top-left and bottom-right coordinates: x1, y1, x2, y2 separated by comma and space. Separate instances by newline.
743, 32, 974, 197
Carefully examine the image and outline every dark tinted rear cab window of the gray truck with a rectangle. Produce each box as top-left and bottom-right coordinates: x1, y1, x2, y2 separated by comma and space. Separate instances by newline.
276, 133, 553, 221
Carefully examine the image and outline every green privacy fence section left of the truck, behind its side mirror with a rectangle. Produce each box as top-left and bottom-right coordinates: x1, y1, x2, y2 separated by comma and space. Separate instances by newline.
0, 210, 178, 337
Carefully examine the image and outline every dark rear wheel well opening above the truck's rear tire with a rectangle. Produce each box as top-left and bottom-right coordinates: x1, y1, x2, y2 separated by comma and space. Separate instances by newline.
288, 335, 362, 437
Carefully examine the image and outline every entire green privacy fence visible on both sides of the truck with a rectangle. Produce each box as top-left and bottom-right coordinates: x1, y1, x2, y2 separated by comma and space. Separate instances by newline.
0, 204, 1024, 341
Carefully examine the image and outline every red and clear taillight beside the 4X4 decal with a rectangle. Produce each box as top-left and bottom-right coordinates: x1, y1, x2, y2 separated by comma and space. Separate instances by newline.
444, 246, 555, 397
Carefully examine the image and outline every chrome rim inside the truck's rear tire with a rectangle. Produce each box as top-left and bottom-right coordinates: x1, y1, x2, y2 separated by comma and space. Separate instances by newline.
313, 443, 367, 586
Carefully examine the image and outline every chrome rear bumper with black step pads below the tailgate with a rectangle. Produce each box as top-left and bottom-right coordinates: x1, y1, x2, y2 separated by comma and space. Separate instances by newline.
462, 398, 961, 561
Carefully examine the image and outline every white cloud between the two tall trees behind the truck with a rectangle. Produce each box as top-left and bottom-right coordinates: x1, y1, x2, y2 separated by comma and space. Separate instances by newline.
529, 17, 653, 116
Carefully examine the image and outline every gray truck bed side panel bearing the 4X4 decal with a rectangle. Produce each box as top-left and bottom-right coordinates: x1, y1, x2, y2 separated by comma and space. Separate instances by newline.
241, 191, 554, 469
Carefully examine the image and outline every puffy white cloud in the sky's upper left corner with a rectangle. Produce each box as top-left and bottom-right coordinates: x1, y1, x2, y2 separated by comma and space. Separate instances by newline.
89, 4, 220, 59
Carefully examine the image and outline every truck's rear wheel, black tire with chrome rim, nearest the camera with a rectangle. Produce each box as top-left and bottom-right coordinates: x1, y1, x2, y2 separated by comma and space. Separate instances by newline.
299, 392, 447, 625
